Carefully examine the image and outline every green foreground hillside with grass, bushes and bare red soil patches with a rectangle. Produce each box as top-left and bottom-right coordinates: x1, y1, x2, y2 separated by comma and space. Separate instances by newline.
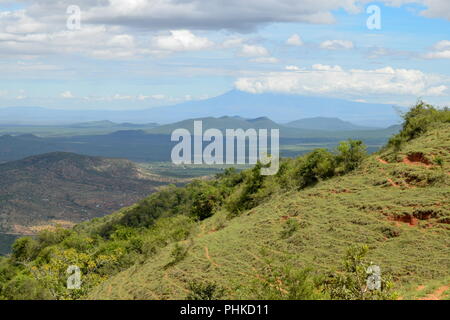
0, 103, 450, 299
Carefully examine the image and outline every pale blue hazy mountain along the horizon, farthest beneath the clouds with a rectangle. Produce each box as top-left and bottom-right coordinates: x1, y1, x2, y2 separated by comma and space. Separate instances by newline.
0, 90, 399, 127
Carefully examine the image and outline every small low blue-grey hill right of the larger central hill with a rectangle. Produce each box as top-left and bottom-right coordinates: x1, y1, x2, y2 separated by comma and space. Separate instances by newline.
286, 117, 377, 131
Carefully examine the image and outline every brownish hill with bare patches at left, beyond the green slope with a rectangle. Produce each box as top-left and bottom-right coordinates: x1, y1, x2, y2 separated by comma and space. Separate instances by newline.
0, 152, 171, 234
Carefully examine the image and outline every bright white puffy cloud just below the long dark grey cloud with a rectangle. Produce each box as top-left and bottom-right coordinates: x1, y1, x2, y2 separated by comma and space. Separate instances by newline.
153, 30, 214, 51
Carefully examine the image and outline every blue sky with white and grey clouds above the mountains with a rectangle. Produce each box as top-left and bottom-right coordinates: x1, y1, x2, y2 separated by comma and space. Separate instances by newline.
0, 0, 450, 110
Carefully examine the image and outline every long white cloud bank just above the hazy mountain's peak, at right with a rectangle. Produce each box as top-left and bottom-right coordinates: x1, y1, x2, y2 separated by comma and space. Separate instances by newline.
235, 64, 450, 97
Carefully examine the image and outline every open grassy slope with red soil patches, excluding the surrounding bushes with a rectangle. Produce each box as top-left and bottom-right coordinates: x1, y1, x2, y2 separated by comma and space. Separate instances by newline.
90, 124, 450, 299
